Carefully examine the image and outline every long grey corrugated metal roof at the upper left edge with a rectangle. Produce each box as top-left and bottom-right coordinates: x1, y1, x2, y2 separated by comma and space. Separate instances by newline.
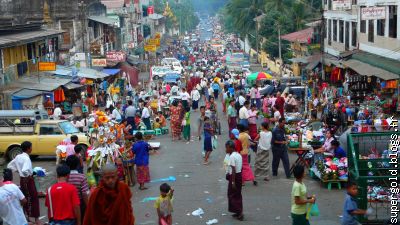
0, 29, 65, 48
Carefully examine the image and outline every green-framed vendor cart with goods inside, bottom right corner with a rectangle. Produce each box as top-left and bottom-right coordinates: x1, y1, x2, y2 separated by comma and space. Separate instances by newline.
347, 132, 400, 224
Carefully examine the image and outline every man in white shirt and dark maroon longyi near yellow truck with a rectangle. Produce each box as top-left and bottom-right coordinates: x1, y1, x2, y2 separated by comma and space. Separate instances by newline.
7, 141, 40, 224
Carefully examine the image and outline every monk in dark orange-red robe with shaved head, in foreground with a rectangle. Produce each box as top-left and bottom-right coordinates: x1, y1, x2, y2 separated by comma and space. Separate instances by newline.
83, 164, 135, 225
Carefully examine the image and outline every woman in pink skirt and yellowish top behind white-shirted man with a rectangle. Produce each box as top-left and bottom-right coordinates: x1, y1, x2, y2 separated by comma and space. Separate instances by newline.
238, 124, 257, 185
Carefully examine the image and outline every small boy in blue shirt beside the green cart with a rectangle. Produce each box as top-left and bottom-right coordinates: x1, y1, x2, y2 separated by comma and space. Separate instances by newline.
342, 181, 368, 225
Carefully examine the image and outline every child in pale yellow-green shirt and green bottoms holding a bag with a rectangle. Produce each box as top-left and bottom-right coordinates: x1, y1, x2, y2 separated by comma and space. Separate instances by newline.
291, 165, 315, 225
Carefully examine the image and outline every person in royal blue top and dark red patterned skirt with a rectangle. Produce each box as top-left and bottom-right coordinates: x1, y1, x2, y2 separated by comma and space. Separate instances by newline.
132, 132, 151, 190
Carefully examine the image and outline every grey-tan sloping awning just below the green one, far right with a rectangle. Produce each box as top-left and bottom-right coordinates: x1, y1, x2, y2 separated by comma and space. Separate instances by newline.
342, 59, 400, 80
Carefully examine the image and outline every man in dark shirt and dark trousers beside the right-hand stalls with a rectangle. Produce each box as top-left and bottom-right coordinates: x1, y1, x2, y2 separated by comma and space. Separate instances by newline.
271, 118, 290, 179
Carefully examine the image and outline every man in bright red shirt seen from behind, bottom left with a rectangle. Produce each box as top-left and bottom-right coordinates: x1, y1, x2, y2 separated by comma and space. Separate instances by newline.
45, 164, 82, 225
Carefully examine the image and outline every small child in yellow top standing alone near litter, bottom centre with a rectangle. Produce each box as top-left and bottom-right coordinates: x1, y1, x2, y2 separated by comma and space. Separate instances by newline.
154, 183, 174, 225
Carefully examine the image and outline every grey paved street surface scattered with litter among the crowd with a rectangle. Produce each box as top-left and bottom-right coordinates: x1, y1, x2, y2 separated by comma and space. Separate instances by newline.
1, 97, 345, 225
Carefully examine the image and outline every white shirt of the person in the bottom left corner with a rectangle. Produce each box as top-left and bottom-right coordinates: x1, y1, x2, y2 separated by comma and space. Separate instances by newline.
0, 184, 28, 225
